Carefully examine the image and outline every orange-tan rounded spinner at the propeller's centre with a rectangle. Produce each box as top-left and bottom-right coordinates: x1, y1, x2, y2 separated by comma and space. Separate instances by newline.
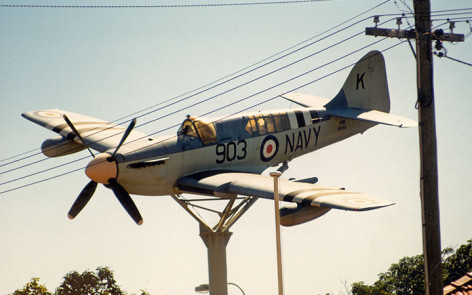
85, 154, 118, 184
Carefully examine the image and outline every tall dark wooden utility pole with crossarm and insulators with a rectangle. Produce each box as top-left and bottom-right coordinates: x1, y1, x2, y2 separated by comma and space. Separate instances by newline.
366, 0, 464, 295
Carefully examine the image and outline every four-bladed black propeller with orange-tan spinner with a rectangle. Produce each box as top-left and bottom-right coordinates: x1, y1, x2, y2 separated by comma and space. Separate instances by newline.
63, 115, 143, 225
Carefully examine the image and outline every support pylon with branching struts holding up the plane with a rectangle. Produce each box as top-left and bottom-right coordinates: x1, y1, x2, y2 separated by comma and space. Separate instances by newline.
172, 195, 257, 295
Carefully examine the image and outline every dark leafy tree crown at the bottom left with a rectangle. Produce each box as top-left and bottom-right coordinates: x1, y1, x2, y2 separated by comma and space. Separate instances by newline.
55, 267, 126, 295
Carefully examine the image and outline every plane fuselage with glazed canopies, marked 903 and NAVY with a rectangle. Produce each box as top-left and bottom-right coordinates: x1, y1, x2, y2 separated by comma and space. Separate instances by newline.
118, 108, 375, 196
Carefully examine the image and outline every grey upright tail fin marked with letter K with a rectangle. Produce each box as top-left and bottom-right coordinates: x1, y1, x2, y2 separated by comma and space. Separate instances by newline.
325, 51, 390, 113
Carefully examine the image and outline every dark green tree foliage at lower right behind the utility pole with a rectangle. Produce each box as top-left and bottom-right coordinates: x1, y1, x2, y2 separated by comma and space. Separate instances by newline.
351, 239, 472, 295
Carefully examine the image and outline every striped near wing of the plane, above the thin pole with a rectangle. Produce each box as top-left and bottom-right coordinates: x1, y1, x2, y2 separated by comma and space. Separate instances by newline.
177, 172, 394, 211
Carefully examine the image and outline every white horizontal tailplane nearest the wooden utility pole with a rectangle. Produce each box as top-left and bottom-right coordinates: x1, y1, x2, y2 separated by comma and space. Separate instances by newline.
326, 108, 418, 128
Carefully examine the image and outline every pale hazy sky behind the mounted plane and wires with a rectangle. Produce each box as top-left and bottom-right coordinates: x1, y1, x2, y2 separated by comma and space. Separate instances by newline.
0, 0, 472, 295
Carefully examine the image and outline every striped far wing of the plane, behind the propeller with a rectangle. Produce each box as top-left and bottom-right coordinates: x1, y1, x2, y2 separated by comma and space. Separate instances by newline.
22, 109, 147, 152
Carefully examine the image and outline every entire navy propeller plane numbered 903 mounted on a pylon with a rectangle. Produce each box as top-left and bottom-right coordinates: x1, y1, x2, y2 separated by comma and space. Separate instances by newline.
22, 51, 417, 226
